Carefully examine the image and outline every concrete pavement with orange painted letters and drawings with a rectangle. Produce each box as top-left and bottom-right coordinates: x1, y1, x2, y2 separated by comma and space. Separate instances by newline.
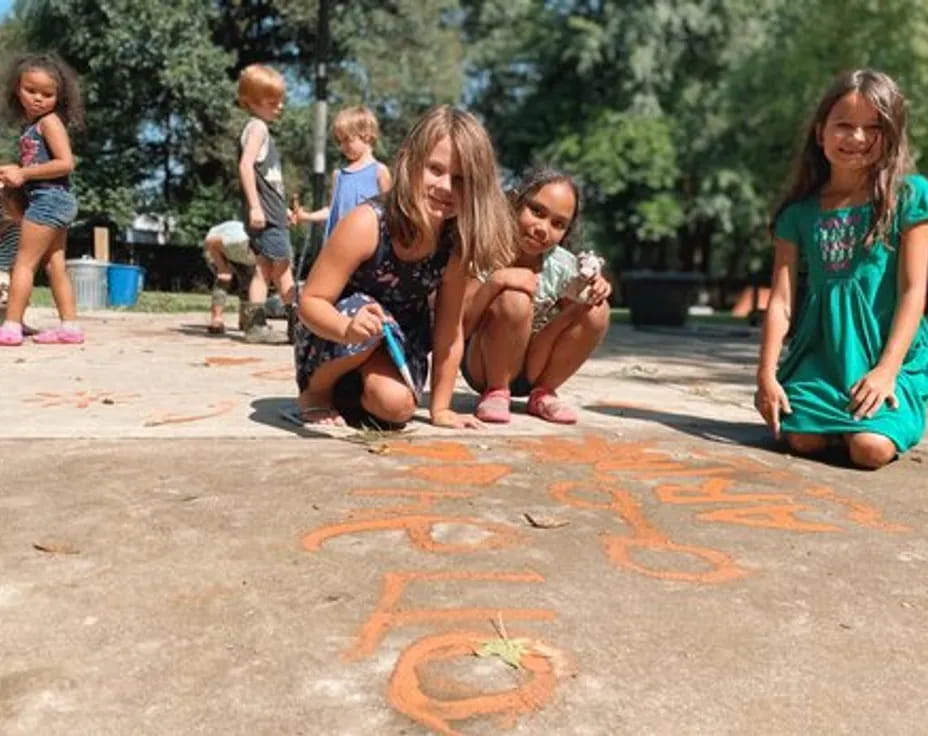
0, 310, 928, 736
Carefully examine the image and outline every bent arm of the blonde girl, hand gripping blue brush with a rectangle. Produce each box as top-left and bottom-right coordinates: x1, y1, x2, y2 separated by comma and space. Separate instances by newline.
300, 207, 384, 344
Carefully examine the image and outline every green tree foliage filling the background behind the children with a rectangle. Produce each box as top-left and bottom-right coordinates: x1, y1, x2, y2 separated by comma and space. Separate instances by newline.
7, 0, 928, 274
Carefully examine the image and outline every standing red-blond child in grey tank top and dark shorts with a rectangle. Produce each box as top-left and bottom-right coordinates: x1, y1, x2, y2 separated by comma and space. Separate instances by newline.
238, 64, 293, 343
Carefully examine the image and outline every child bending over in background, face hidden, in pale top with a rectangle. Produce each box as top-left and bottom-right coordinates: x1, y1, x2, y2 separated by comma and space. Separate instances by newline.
203, 220, 255, 335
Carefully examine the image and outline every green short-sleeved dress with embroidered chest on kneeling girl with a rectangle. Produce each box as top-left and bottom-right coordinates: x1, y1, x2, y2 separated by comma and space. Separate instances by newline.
775, 175, 928, 452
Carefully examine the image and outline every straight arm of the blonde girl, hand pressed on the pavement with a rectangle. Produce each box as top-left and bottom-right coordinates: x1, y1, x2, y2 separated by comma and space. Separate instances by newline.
429, 251, 481, 428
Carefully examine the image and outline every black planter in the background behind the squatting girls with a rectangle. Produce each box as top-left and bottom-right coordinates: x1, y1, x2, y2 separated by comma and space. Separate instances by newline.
622, 271, 705, 327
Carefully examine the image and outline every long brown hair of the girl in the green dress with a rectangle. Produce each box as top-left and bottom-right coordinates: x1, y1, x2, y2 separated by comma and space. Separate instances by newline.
773, 69, 912, 247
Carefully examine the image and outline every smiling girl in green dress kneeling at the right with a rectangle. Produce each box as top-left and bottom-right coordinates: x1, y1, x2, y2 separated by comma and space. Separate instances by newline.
755, 69, 928, 468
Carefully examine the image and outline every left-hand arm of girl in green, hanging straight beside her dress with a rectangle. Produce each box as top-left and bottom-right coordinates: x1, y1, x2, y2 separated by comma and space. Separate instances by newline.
755, 238, 799, 437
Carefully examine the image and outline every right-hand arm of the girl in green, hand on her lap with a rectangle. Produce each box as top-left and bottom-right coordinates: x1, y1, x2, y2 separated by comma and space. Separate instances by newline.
848, 223, 928, 419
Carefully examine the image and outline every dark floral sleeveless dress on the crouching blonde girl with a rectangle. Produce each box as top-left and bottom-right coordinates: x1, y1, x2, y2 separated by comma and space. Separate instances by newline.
294, 200, 453, 392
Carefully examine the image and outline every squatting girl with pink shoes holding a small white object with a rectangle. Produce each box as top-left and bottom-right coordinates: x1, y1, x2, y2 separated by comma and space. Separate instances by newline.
461, 168, 612, 424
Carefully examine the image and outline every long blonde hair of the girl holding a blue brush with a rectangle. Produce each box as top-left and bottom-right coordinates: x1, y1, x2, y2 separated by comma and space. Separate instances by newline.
386, 105, 516, 273
